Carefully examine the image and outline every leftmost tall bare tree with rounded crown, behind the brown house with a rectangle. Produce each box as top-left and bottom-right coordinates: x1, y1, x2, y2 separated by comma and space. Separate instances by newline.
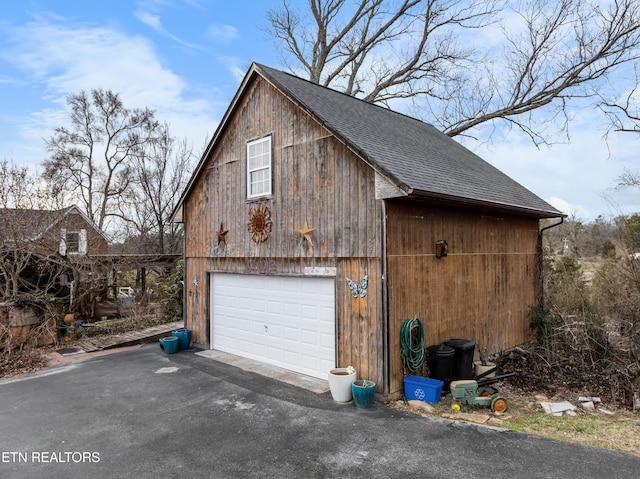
43, 89, 158, 230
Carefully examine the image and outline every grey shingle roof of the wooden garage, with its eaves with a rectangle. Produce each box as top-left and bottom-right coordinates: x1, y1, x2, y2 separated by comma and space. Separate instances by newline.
176, 63, 564, 218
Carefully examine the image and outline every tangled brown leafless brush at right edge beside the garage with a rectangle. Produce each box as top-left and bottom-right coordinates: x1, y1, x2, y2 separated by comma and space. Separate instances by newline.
509, 257, 640, 407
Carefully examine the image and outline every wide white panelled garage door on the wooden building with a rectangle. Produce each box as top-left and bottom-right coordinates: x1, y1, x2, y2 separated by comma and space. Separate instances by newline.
211, 273, 335, 379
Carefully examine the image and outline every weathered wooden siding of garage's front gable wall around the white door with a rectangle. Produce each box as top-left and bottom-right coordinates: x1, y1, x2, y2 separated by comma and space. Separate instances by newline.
184, 78, 384, 390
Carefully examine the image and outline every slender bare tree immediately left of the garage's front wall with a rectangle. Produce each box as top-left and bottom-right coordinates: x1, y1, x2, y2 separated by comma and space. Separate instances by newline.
119, 123, 195, 253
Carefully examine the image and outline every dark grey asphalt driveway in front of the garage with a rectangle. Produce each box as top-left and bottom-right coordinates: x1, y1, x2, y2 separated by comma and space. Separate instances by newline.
0, 344, 640, 479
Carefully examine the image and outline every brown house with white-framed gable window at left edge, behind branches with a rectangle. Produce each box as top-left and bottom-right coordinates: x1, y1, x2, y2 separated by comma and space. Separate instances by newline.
0, 206, 108, 347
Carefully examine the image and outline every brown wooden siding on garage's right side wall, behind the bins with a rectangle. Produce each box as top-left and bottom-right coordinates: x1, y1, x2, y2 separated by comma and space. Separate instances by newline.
386, 201, 538, 392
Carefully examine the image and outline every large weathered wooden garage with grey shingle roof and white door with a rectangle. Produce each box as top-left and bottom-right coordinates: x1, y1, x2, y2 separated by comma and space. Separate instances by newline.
173, 64, 564, 394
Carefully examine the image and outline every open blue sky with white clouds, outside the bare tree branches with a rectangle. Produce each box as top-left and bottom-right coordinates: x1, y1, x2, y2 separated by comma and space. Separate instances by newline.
0, 0, 640, 221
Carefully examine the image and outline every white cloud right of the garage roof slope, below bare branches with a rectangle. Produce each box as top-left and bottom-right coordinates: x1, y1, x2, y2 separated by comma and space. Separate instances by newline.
463, 110, 640, 220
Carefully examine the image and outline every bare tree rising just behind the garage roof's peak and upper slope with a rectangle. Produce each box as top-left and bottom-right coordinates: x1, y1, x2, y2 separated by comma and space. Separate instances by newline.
267, 0, 499, 98
